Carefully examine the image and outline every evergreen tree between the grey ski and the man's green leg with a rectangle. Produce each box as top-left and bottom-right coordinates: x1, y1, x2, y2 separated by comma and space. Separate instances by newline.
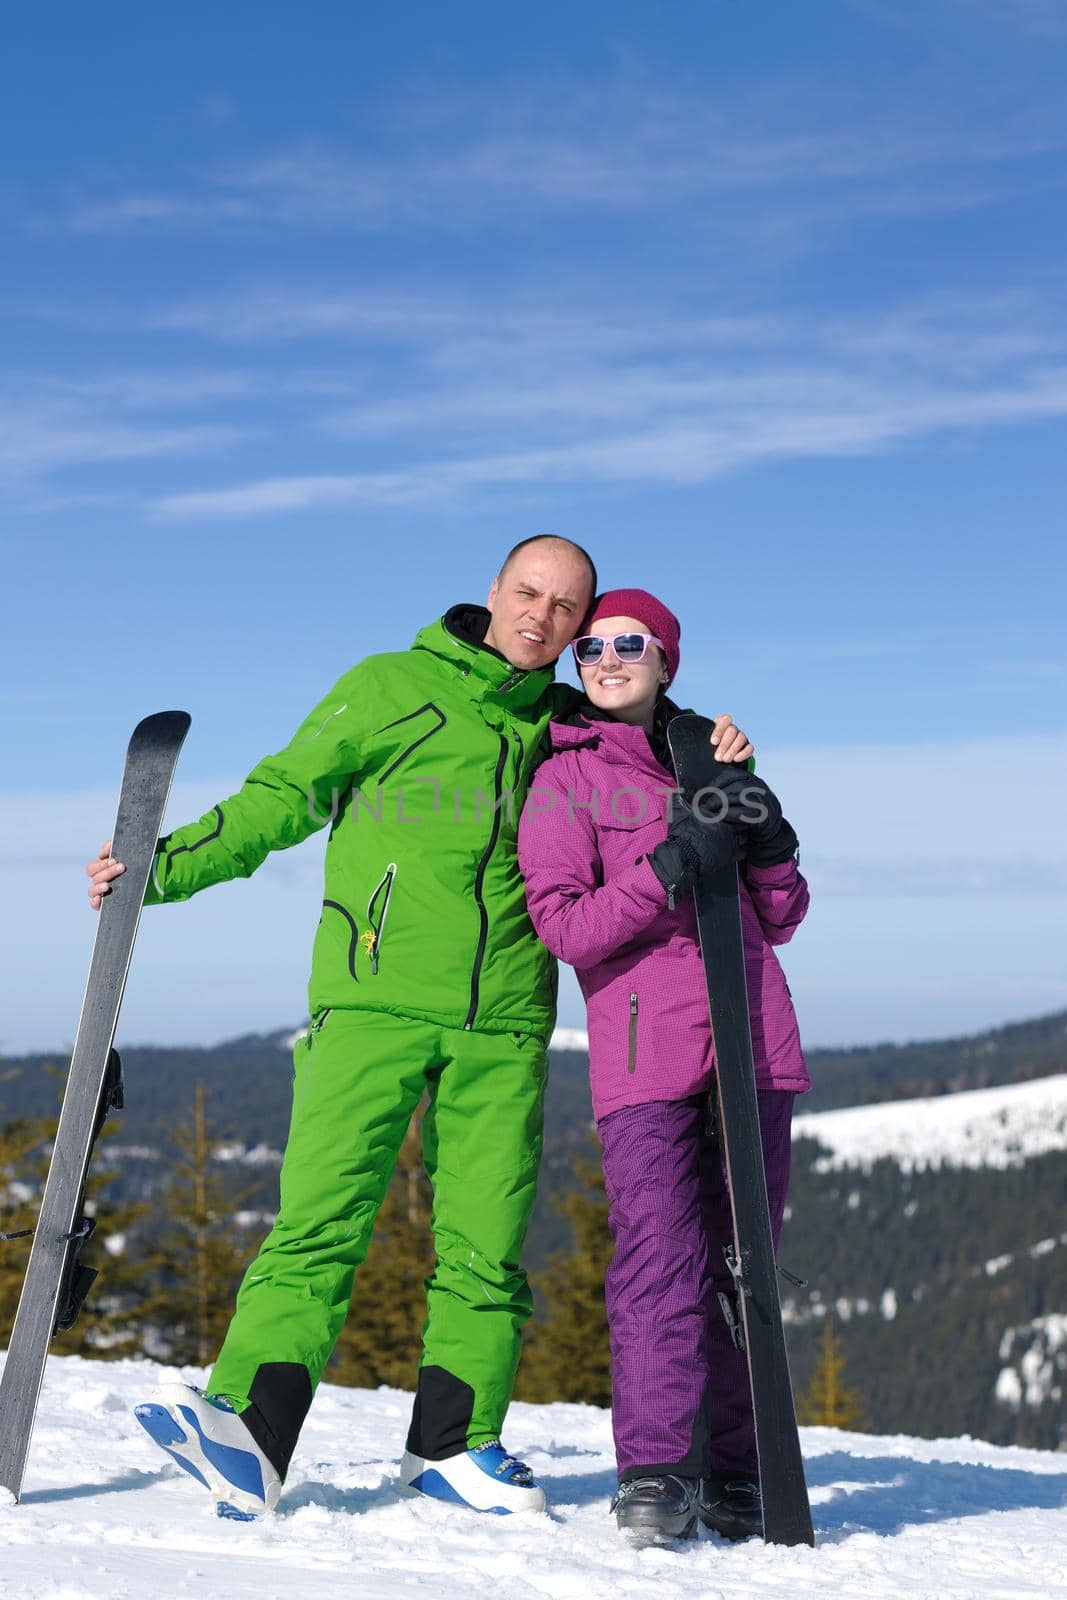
142, 1083, 263, 1366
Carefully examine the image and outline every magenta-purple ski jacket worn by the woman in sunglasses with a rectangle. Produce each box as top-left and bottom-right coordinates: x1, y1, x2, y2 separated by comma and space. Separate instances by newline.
518, 718, 811, 1122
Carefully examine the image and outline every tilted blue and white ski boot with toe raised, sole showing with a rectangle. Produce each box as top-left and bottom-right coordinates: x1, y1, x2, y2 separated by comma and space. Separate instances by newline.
133, 1384, 282, 1522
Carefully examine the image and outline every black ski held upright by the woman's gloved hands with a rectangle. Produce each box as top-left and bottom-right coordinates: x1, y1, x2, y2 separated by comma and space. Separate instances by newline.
667, 714, 814, 1544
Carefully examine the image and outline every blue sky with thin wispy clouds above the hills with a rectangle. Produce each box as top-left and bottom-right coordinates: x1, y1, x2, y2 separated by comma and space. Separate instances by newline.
0, 0, 1067, 1050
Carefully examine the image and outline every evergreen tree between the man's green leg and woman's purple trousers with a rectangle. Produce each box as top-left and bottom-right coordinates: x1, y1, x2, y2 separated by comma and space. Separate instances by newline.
515, 1155, 613, 1406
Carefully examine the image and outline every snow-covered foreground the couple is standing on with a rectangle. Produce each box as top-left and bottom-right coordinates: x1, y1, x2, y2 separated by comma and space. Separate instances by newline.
0, 1357, 1067, 1600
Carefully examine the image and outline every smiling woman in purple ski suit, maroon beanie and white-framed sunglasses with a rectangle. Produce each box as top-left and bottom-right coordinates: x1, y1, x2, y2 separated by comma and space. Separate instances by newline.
518, 589, 811, 1538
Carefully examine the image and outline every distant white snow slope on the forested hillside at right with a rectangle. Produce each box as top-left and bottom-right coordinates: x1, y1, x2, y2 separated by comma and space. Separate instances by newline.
793, 1072, 1067, 1171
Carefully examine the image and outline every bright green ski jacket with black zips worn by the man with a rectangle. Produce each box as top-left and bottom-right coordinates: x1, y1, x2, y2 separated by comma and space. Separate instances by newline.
146, 606, 573, 1042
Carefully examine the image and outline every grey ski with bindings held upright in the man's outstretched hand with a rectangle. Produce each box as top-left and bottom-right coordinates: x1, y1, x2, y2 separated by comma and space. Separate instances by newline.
0, 710, 190, 1501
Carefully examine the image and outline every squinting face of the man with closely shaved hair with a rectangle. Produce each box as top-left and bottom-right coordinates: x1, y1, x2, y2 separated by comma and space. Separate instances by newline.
485, 539, 592, 672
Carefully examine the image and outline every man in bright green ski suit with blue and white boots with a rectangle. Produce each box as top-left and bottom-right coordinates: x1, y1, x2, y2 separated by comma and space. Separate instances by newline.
88, 538, 747, 1517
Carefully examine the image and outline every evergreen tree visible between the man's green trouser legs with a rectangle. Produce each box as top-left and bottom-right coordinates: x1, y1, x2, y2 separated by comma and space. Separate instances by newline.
326, 1115, 434, 1389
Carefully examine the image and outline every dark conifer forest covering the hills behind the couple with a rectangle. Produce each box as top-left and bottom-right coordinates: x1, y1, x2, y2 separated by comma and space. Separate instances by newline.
0, 1024, 1067, 1448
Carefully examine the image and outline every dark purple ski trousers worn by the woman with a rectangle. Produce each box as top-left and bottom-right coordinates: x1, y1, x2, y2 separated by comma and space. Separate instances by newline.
597, 1090, 795, 1480
